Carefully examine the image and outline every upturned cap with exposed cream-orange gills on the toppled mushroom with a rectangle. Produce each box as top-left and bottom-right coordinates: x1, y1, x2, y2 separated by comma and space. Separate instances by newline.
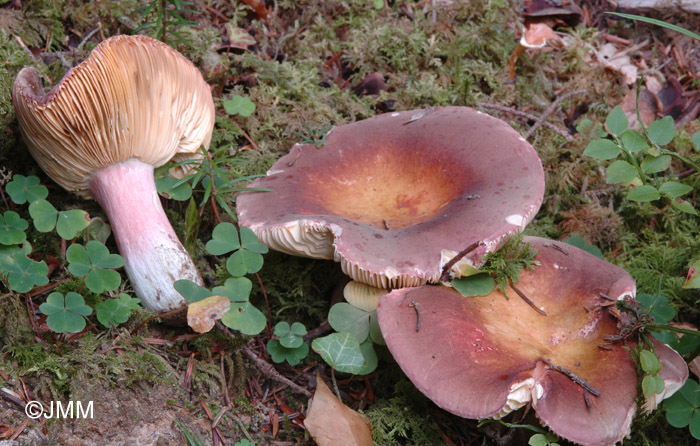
12, 36, 214, 197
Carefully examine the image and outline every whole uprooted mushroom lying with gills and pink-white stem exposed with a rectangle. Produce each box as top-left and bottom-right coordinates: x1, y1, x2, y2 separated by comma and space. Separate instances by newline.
12, 36, 214, 311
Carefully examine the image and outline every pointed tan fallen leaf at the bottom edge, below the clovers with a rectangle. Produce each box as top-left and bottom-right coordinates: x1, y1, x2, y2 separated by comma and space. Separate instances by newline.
304, 373, 373, 446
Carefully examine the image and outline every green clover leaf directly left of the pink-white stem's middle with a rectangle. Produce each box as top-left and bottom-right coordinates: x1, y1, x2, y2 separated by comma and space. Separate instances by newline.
66, 240, 124, 294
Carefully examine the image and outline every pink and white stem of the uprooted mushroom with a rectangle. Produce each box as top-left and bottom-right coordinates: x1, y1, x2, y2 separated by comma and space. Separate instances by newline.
89, 159, 203, 312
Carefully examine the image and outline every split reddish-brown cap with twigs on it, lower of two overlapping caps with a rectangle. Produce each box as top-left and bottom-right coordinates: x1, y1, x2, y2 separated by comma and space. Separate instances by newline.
377, 237, 688, 445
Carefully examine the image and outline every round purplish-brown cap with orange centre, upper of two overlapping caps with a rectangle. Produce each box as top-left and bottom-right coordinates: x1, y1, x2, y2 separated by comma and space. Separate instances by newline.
236, 107, 544, 288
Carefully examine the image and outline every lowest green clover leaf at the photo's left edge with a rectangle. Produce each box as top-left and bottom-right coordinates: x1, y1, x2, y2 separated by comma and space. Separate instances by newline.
0, 248, 49, 293
